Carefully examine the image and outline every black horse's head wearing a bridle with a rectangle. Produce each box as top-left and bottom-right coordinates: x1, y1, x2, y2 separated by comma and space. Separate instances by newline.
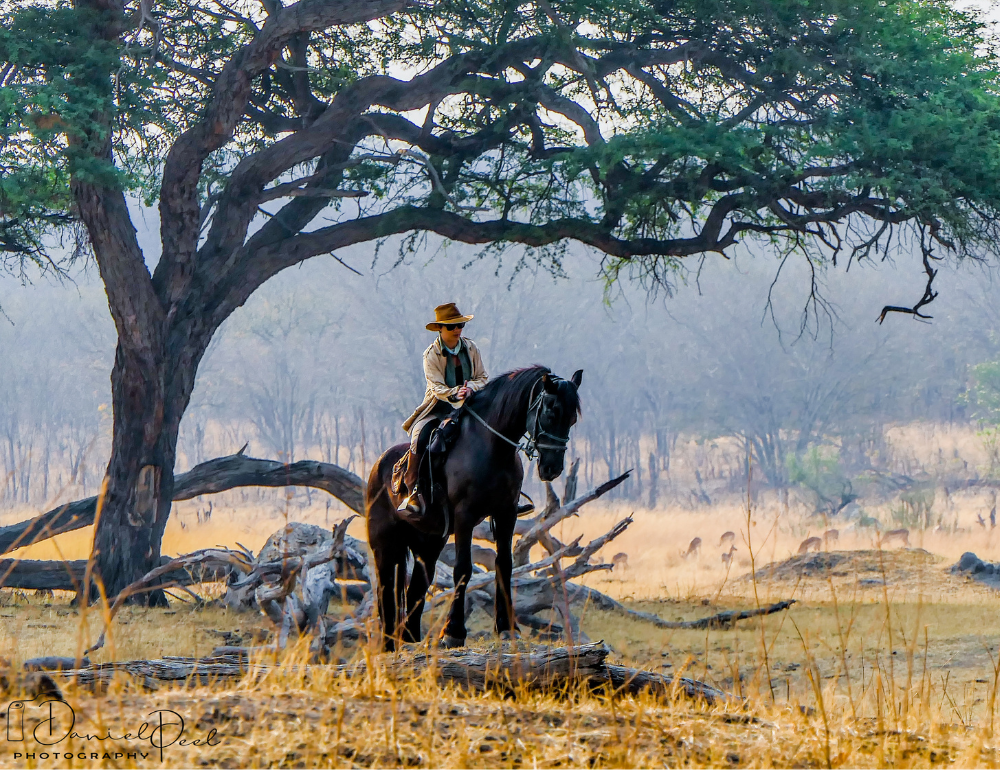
527, 369, 583, 481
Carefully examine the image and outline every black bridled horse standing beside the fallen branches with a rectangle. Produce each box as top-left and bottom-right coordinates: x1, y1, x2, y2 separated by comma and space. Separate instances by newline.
365, 366, 583, 650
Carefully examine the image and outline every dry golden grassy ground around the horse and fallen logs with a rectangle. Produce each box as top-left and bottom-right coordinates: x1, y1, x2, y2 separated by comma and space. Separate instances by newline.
0, 476, 1000, 767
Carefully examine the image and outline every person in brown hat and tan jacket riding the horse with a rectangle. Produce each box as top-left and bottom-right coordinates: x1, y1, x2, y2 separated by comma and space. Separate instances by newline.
398, 302, 486, 517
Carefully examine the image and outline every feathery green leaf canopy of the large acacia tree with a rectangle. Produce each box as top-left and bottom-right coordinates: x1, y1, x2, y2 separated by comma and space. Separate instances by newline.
0, 0, 1000, 282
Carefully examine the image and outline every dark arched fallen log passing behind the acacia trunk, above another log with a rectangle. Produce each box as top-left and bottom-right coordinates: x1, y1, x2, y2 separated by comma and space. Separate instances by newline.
0, 446, 365, 553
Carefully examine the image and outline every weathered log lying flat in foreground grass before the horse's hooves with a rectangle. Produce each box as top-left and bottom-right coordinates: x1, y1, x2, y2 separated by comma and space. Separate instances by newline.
49, 642, 738, 704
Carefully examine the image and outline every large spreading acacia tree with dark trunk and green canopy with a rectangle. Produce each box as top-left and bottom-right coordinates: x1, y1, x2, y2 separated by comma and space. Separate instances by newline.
0, 0, 1000, 593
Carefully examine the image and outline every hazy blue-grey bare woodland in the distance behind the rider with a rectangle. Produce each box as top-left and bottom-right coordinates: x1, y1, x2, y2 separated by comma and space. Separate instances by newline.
0, 234, 1000, 506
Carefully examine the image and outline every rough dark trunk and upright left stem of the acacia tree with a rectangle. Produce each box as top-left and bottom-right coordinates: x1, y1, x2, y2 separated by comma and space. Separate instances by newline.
68, 0, 173, 605
